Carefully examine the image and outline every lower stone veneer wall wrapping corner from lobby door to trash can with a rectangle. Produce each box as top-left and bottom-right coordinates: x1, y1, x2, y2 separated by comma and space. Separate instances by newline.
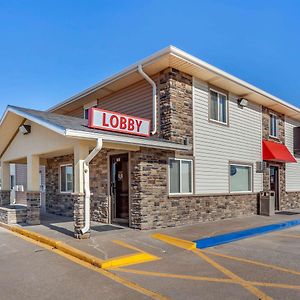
131, 148, 257, 229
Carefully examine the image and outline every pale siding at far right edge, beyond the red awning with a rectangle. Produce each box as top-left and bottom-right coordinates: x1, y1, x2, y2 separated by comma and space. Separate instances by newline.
285, 118, 300, 192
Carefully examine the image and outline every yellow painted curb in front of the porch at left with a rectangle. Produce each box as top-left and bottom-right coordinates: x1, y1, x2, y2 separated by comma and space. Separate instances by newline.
0, 222, 104, 268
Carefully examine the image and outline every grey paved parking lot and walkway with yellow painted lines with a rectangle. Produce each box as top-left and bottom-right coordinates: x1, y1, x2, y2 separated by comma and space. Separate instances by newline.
0, 211, 300, 299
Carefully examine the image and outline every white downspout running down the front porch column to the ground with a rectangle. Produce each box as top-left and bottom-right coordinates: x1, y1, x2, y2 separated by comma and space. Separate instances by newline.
81, 139, 103, 234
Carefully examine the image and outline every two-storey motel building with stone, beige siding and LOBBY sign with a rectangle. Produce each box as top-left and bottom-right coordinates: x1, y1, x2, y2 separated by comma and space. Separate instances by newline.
0, 46, 300, 238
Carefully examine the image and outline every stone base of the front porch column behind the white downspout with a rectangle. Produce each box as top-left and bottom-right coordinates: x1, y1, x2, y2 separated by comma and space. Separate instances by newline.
73, 193, 90, 239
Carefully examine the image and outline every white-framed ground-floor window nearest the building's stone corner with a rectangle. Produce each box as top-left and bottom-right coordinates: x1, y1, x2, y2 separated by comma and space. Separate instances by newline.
169, 158, 193, 194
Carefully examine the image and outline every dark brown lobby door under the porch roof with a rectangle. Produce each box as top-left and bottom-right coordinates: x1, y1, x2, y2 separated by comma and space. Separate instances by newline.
110, 154, 129, 223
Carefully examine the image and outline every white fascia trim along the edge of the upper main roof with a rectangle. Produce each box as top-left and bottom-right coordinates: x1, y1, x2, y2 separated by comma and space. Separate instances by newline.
48, 46, 300, 115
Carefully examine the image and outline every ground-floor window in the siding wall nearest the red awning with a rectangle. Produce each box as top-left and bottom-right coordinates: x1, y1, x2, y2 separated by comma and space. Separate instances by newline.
230, 164, 252, 192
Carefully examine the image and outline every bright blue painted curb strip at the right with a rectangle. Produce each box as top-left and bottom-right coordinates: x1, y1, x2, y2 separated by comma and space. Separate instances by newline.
194, 219, 300, 249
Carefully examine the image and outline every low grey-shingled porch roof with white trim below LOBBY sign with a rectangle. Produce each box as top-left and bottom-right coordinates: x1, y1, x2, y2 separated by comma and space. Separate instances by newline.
0, 105, 191, 157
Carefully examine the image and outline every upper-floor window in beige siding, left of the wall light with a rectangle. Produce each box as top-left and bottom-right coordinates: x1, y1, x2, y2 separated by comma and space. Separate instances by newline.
210, 90, 227, 124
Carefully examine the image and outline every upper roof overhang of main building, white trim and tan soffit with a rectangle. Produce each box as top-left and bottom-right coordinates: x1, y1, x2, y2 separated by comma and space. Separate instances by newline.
48, 46, 300, 120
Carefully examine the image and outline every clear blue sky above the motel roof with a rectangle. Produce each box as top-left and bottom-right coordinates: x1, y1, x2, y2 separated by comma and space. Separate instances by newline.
0, 0, 300, 113
